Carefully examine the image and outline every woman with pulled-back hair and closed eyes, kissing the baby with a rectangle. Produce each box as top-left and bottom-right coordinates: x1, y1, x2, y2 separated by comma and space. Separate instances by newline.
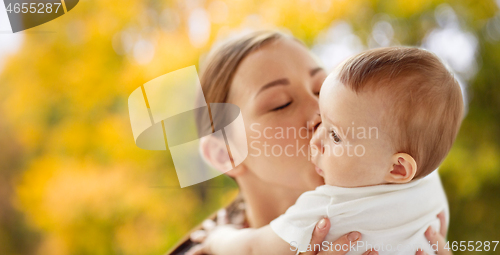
184, 31, 449, 254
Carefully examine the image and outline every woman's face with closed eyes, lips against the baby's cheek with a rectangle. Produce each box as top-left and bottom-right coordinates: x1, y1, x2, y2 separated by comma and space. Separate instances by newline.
228, 39, 326, 190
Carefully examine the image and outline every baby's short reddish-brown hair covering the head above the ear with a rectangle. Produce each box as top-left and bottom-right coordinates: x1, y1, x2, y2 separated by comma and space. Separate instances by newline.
337, 47, 464, 179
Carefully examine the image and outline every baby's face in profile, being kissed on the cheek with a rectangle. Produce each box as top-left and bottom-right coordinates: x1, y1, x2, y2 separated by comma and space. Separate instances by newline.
311, 74, 396, 187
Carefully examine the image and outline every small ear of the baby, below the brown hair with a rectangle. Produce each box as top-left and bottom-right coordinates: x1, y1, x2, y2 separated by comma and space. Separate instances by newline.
385, 153, 417, 183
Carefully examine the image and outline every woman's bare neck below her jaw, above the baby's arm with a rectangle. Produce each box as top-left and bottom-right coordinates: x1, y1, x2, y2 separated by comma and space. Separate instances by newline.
237, 171, 306, 228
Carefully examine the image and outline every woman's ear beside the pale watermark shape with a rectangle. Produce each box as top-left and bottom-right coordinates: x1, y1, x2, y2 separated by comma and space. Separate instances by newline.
200, 135, 244, 177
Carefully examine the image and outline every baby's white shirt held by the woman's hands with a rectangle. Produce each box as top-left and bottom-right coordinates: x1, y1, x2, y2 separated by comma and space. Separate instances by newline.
270, 171, 449, 255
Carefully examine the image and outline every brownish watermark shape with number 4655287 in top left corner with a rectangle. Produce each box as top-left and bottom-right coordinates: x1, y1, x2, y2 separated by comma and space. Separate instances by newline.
3, 0, 78, 33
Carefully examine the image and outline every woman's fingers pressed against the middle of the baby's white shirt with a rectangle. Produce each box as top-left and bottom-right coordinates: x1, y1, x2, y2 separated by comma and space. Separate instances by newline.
304, 218, 378, 255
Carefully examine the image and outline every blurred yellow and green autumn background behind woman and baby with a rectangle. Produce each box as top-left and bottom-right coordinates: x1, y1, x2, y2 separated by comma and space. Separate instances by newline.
0, 0, 500, 255
